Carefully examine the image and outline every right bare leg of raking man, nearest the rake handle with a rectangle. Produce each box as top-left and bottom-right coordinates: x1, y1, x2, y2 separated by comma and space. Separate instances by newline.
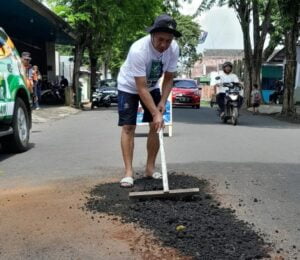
145, 123, 159, 176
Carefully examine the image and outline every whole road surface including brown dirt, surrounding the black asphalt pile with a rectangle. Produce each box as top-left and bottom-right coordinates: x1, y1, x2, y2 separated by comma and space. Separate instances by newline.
0, 104, 300, 259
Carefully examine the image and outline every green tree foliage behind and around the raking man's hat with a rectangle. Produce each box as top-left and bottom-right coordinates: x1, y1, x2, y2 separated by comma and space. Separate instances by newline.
48, 0, 200, 75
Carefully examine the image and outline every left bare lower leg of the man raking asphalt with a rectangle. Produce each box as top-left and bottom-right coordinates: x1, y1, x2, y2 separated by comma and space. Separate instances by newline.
121, 125, 136, 182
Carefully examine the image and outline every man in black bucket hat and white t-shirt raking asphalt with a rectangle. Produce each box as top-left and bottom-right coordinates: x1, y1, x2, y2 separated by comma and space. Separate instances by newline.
118, 14, 181, 188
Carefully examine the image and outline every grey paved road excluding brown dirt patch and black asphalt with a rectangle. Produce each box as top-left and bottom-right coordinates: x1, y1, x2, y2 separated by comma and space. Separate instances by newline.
0, 104, 300, 256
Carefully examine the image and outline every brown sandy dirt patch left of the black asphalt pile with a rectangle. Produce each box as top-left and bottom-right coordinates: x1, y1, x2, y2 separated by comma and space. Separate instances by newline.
0, 179, 188, 260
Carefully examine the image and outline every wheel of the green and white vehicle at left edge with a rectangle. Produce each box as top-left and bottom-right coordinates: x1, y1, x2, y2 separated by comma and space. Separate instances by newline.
3, 98, 30, 153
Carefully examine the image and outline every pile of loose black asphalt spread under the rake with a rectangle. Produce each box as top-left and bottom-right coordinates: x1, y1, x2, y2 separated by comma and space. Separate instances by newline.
85, 174, 270, 260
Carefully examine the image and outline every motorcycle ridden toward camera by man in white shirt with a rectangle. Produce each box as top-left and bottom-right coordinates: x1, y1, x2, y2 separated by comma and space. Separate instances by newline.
220, 82, 242, 125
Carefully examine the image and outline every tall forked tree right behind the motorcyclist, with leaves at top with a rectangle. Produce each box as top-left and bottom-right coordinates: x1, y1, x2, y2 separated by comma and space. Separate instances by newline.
198, 0, 277, 105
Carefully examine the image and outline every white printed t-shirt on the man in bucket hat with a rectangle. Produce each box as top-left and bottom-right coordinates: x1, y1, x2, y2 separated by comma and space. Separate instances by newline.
118, 35, 179, 94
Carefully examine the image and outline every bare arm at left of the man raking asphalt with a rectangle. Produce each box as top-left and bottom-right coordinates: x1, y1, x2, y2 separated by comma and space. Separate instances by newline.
134, 77, 163, 131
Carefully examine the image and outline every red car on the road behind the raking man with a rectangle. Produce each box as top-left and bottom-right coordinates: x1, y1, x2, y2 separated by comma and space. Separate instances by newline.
172, 79, 201, 109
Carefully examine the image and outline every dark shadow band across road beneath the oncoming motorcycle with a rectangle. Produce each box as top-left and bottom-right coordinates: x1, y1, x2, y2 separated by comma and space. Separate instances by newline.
173, 107, 300, 129
